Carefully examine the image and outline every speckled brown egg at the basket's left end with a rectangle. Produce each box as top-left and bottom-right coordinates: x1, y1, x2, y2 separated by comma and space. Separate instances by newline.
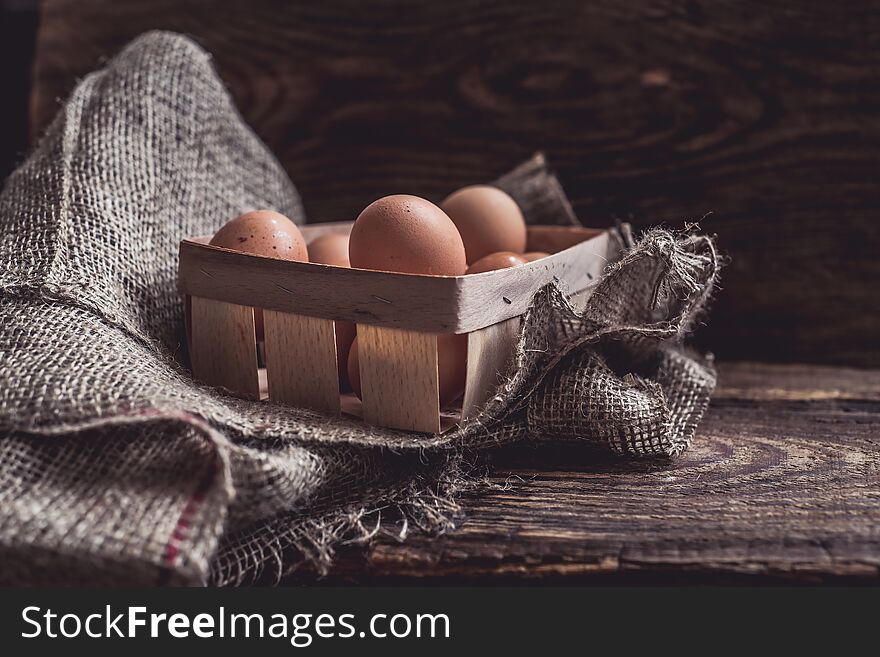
210, 210, 309, 340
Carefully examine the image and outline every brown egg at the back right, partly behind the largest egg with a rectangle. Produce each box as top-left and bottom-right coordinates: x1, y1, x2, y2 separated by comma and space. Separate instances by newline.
440, 185, 526, 264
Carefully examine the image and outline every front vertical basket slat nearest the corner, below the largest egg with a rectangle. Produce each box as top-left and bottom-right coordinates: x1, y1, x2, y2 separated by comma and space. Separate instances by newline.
357, 324, 440, 433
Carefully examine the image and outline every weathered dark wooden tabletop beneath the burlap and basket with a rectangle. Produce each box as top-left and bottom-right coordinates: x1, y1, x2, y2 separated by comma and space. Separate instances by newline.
304, 363, 880, 584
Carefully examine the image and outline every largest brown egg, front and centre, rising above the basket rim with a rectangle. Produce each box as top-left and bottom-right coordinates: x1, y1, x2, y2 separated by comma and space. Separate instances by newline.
348, 194, 467, 276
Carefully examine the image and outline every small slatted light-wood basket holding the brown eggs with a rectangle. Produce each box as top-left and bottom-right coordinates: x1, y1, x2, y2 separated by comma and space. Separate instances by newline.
178, 222, 616, 432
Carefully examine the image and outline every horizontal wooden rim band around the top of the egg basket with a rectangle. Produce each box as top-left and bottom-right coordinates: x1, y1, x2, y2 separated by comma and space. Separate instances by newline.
178, 226, 614, 334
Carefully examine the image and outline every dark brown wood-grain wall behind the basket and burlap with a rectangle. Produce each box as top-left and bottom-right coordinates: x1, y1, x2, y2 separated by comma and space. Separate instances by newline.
32, 0, 880, 367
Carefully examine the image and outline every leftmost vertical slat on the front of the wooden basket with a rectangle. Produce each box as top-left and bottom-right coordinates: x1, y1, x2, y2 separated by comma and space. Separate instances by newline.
190, 297, 260, 399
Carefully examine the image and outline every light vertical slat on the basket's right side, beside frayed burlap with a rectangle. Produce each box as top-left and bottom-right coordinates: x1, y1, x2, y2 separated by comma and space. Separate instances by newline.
461, 317, 522, 419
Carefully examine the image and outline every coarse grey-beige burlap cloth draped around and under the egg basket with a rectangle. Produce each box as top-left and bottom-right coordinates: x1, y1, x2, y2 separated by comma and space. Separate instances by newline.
0, 33, 718, 584
